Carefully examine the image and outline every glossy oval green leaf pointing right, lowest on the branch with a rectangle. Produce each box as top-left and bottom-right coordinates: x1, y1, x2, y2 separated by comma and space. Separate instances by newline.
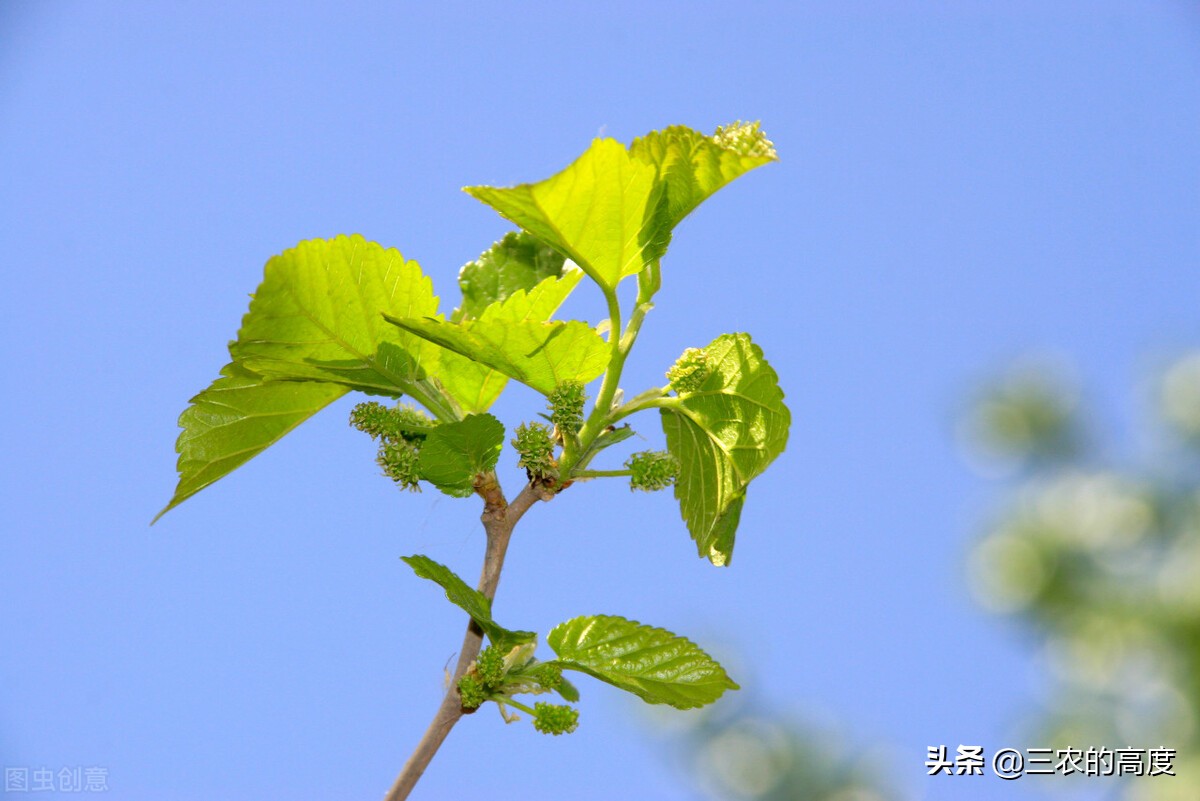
546, 615, 738, 709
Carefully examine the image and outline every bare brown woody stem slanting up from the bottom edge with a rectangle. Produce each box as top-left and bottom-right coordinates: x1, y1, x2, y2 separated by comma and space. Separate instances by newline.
384, 472, 553, 801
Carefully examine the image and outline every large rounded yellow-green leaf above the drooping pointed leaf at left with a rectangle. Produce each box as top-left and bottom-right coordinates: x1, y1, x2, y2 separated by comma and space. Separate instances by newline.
229, 235, 457, 418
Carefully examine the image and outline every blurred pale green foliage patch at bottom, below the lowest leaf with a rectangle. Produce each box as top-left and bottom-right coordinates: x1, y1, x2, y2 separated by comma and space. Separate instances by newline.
659, 691, 905, 801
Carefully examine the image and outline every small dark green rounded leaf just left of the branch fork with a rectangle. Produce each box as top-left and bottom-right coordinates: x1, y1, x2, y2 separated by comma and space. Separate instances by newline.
416, 415, 504, 498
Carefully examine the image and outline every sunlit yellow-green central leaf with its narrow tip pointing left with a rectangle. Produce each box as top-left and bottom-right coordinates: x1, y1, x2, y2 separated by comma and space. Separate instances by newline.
386, 315, 608, 395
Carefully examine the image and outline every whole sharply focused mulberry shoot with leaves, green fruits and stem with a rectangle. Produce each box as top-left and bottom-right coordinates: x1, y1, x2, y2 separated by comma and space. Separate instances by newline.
162, 122, 791, 801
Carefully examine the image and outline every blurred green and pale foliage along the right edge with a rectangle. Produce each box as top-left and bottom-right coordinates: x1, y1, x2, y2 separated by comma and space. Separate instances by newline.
965, 356, 1200, 801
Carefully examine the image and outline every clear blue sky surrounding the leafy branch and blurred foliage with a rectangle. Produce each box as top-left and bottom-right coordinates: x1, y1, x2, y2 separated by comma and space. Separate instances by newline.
0, 0, 1200, 801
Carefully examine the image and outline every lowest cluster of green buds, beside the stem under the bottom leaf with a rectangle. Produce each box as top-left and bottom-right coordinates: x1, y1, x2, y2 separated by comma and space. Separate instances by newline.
458, 643, 580, 735
